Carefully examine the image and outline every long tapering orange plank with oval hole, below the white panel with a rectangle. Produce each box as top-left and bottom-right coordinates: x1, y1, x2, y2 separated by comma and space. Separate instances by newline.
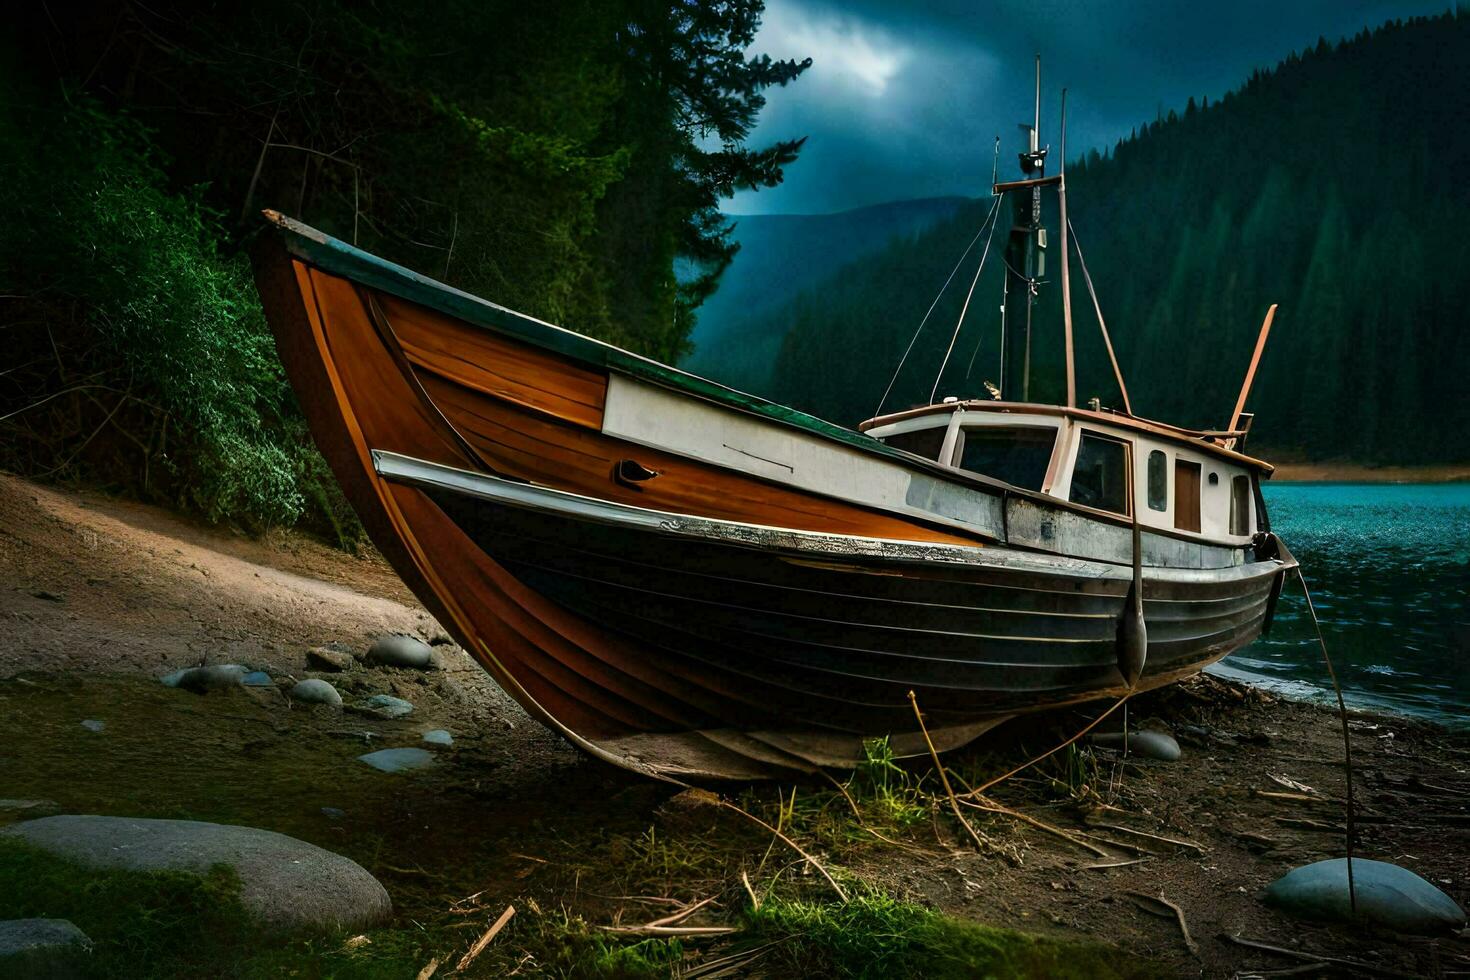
420, 373, 975, 544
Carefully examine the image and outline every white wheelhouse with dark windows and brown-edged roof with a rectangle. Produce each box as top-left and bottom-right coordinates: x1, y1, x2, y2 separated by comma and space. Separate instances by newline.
860, 401, 1270, 547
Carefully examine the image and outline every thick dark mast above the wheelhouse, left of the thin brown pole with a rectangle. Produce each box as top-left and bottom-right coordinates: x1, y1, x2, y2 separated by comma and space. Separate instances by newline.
997, 54, 1047, 401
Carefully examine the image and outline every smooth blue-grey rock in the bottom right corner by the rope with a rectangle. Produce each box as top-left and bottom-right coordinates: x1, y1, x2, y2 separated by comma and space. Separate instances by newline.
1264, 858, 1466, 936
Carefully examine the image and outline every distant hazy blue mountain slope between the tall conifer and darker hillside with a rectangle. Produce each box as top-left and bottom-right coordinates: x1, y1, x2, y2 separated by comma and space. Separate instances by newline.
682, 197, 966, 388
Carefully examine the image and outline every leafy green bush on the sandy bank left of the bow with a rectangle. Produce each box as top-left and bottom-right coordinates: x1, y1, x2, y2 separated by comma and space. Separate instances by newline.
0, 100, 356, 541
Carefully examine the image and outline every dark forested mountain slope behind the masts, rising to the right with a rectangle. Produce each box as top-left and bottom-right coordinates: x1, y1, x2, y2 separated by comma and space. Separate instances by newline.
769, 13, 1470, 461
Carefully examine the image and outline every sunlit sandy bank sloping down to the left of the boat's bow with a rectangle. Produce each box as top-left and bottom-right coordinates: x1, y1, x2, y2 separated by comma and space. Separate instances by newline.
0, 475, 575, 765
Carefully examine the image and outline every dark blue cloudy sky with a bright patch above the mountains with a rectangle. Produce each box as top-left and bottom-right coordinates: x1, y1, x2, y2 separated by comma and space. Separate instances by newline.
726, 0, 1448, 213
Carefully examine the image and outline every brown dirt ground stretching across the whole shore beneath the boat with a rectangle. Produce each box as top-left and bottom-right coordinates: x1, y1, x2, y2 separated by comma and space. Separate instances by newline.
0, 476, 1470, 977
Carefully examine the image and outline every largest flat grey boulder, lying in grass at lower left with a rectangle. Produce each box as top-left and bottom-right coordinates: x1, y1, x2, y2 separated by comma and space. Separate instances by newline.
0, 815, 392, 932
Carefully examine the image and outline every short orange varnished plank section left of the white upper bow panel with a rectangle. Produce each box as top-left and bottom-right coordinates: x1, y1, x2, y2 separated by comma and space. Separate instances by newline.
378, 294, 607, 429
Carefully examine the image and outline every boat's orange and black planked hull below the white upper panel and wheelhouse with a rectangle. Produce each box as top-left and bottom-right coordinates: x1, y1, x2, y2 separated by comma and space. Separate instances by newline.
257, 214, 1288, 777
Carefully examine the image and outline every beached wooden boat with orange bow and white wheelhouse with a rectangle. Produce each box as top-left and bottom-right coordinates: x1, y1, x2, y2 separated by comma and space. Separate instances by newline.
256, 80, 1295, 777
